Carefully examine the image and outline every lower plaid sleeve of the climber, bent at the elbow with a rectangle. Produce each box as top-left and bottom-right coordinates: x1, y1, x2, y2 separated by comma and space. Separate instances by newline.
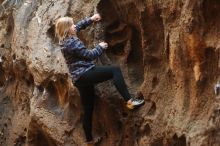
71, 40, 104, 60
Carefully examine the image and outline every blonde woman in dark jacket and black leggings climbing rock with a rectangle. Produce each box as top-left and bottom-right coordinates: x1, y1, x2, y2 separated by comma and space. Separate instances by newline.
55, 14, 144, 145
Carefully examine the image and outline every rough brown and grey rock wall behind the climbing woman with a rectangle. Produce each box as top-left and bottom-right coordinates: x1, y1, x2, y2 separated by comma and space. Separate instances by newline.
0, 0, 220, 146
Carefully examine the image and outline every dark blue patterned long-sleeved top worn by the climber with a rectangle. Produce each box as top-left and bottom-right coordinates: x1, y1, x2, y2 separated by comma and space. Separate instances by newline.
61, 18, 104, 83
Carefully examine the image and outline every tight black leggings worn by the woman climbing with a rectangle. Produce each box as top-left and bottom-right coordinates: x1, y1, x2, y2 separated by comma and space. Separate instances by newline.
75, 66, 131, 141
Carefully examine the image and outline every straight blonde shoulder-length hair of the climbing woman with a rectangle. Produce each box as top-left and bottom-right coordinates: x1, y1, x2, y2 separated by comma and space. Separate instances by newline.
55, 17, 73, 42
